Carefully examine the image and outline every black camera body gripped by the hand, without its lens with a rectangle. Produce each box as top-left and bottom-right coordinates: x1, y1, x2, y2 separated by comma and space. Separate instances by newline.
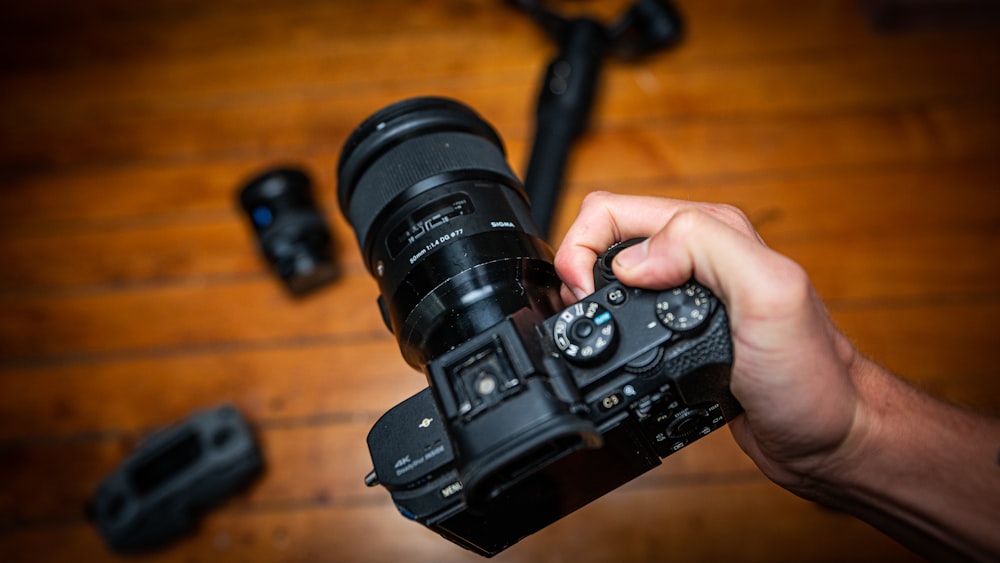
368, 237, 741, 556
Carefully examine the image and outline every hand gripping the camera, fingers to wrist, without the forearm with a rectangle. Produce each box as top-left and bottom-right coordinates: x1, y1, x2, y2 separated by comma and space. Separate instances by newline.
555, 192, 864, 496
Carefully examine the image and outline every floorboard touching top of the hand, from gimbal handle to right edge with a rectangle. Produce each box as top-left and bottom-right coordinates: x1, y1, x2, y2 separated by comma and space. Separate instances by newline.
555, 160, 1000, 245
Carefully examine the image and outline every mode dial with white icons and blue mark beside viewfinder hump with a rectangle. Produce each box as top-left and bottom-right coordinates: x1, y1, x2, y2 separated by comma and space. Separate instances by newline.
552, 301, 617, 363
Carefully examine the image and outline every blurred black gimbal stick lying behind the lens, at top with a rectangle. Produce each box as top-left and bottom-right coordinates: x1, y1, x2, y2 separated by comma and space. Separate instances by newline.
513, 0, 683, 235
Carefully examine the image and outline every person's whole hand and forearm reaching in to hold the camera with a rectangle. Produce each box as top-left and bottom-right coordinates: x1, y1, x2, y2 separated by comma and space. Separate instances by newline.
555, 192, 1000, 561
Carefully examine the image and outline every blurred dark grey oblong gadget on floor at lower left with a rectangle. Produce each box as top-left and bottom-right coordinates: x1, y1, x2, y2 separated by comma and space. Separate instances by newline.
87, 405, 263, 552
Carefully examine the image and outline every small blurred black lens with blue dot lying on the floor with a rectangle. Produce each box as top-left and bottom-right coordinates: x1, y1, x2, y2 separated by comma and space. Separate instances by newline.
239, 168, 337, 295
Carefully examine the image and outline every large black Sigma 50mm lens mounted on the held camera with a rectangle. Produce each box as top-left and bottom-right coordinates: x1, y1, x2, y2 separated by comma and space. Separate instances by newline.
338, 98, 561, 368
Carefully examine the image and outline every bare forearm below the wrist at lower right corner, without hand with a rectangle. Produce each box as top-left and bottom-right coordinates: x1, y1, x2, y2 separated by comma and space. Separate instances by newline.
803, 359, 1000, 561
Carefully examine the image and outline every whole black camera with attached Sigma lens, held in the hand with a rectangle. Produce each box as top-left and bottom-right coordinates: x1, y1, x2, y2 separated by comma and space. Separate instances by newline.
338, 98, 740, 556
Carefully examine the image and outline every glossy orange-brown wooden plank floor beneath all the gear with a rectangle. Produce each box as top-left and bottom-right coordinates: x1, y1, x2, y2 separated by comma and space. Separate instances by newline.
0, 0, 1000, 562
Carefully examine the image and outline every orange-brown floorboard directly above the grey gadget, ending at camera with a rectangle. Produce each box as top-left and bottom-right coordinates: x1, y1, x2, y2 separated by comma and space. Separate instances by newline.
0, 338, 414, 441
